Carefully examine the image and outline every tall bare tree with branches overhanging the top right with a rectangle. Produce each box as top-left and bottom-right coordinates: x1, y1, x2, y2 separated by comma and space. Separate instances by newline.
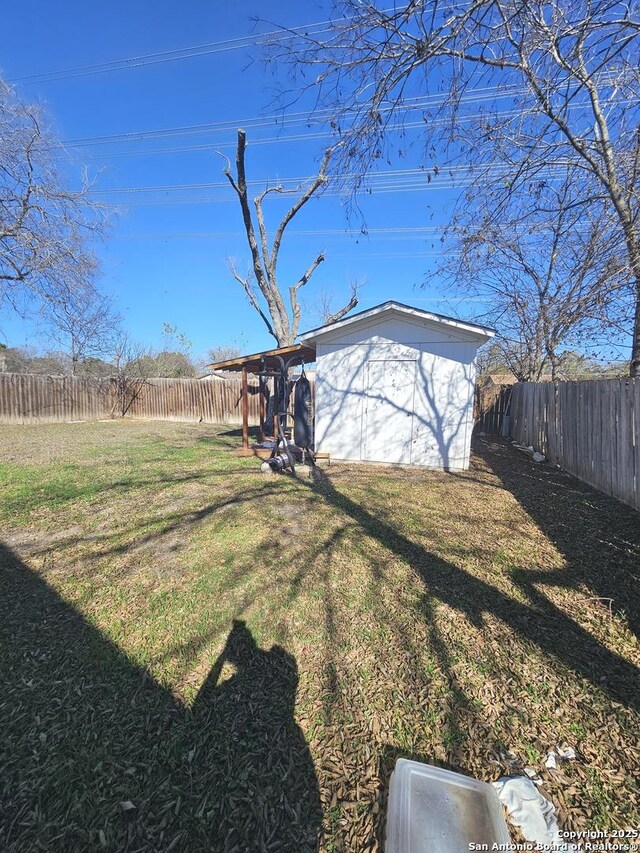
277, 0, 640, 376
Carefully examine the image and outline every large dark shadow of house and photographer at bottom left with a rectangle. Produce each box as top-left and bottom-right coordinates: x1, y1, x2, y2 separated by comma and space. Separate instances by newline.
0, 545, 321, 853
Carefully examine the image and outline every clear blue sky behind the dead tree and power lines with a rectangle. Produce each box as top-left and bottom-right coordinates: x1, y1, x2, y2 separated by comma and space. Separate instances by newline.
0, 0, 482, 354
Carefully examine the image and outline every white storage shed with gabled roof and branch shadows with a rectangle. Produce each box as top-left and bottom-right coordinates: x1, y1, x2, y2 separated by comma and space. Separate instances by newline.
300, 302, 494, 470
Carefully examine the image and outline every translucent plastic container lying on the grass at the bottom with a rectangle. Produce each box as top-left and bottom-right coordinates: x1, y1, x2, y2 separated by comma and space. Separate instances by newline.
385, 758, 511, 853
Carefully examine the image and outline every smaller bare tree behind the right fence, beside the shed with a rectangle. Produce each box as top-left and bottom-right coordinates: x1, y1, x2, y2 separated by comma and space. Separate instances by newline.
449, 169, 633, 381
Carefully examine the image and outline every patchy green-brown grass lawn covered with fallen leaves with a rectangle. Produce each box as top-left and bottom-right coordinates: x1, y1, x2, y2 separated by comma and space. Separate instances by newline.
0, 422, 640, 853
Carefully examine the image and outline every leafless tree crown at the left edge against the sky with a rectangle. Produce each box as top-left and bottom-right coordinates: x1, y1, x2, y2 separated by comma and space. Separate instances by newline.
0, 81, 104, 326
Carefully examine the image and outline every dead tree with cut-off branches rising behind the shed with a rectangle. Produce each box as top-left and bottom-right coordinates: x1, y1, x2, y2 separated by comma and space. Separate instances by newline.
224, 130, 358, 347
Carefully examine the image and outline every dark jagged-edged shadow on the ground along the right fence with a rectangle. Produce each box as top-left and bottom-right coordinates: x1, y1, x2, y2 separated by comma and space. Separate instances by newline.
474, 436, 640, 636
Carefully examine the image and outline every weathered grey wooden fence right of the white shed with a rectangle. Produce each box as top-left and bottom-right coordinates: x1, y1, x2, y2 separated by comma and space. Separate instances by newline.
510, 379, 640, 509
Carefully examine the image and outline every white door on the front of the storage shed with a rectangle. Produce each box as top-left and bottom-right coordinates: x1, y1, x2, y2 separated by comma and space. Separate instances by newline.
362, 360, 416, 464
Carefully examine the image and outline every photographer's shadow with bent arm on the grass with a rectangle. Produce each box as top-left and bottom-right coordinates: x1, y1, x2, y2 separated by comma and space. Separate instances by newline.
191, 619, 322, 853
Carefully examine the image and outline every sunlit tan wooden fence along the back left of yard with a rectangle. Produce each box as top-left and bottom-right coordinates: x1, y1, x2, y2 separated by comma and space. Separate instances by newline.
0, 373, 259, 424
